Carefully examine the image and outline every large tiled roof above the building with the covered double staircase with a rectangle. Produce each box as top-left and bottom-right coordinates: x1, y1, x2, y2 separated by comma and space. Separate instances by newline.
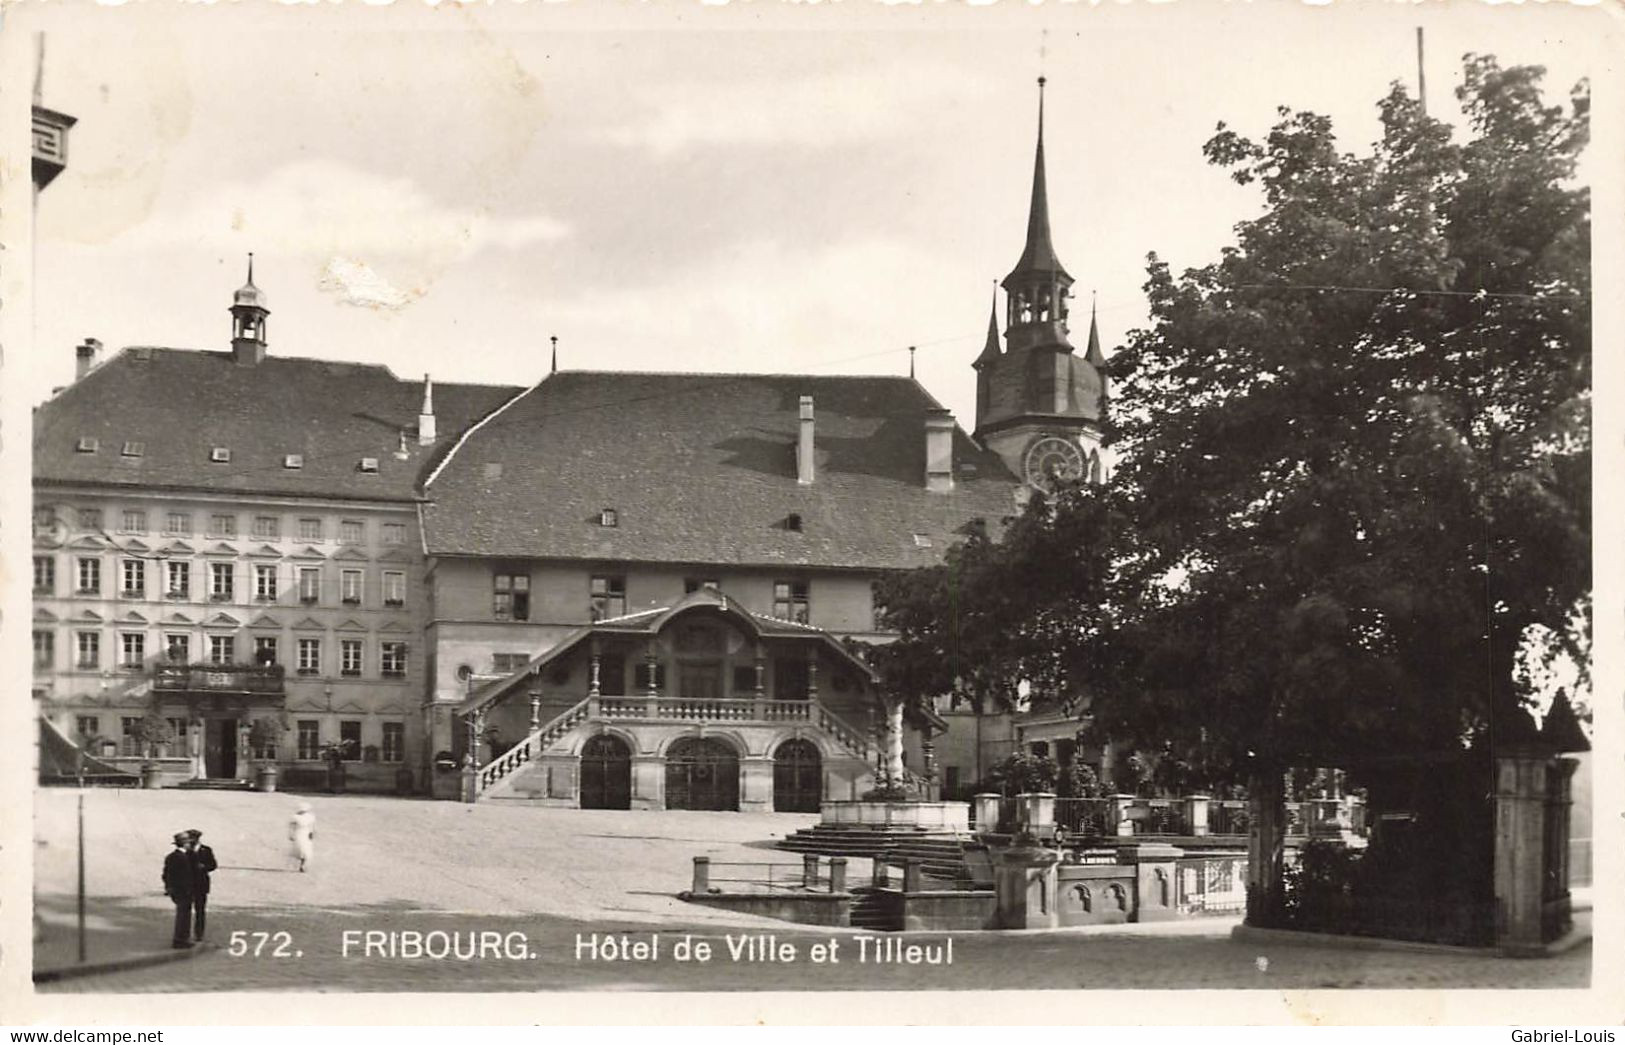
424, 371, 1016, 569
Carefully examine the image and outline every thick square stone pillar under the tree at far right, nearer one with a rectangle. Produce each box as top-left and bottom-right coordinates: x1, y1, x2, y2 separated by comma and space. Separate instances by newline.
1495, 752, 1554, 954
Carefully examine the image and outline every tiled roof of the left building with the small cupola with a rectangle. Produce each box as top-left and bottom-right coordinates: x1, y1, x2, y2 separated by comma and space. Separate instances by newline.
34, 348, 518, 501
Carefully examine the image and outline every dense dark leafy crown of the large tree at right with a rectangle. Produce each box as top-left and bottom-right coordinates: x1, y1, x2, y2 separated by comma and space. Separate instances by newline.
881, 55, 1591, 782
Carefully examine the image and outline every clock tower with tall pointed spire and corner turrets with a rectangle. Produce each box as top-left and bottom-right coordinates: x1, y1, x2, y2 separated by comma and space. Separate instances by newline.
972, 76, 1107, 489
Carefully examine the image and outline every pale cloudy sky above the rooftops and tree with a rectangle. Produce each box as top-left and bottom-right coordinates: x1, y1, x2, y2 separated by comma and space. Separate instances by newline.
28, 0, 1617, 427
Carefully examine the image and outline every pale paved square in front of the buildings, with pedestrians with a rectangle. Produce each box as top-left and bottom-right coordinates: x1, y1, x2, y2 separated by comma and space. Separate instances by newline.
36, 790, 1591, 991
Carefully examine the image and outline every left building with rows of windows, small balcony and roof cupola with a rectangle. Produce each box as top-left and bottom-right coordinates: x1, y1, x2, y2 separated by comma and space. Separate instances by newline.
33, 268, 515, 790
